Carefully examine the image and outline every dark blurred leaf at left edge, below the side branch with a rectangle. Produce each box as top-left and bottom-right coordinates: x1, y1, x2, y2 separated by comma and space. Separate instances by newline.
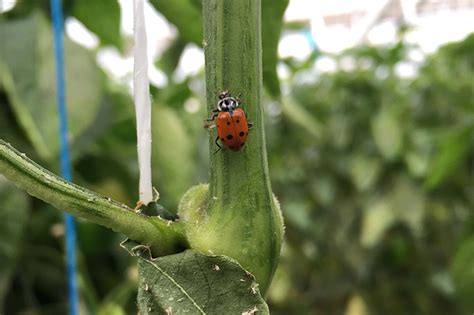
0, 175, 29, 314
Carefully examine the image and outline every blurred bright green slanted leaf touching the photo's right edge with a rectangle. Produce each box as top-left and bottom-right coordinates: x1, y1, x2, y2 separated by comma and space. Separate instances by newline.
425, 124, 474, 188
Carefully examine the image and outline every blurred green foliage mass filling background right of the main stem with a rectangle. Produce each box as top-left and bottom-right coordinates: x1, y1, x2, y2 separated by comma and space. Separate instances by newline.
267, 35, 474, 314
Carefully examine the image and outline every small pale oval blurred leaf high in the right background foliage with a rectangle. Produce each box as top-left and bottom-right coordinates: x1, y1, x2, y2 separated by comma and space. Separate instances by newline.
372, 109, 403, 160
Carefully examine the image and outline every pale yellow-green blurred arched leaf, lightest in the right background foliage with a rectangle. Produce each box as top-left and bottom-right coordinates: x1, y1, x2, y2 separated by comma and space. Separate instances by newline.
360, 178, 425, 248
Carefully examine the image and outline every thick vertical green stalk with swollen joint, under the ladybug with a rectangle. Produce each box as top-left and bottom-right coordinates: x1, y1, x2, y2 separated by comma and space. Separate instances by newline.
180, 0, 283, 294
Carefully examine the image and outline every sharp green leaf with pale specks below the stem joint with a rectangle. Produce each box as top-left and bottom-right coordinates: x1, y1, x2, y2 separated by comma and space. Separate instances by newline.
124, 242, 269, 315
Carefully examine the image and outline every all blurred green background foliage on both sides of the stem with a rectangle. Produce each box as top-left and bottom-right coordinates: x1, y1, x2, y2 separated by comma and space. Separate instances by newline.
0, 0, 474, 315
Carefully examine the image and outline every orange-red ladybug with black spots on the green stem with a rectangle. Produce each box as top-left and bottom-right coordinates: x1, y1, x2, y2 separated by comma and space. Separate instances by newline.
207, 91, 252, 152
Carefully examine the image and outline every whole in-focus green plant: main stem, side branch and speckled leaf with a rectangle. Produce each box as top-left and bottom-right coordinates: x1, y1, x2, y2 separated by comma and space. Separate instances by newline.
0, 0, 283, 314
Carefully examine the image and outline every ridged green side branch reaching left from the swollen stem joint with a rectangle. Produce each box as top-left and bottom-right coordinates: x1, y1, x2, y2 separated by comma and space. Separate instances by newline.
0, 140, 186, 255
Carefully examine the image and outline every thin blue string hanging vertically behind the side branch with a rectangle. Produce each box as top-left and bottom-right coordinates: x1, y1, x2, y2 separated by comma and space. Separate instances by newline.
51, 0, 78, 315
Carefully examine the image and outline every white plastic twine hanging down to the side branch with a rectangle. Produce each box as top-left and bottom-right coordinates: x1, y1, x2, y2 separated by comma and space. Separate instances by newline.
133, 0, 153, 205
